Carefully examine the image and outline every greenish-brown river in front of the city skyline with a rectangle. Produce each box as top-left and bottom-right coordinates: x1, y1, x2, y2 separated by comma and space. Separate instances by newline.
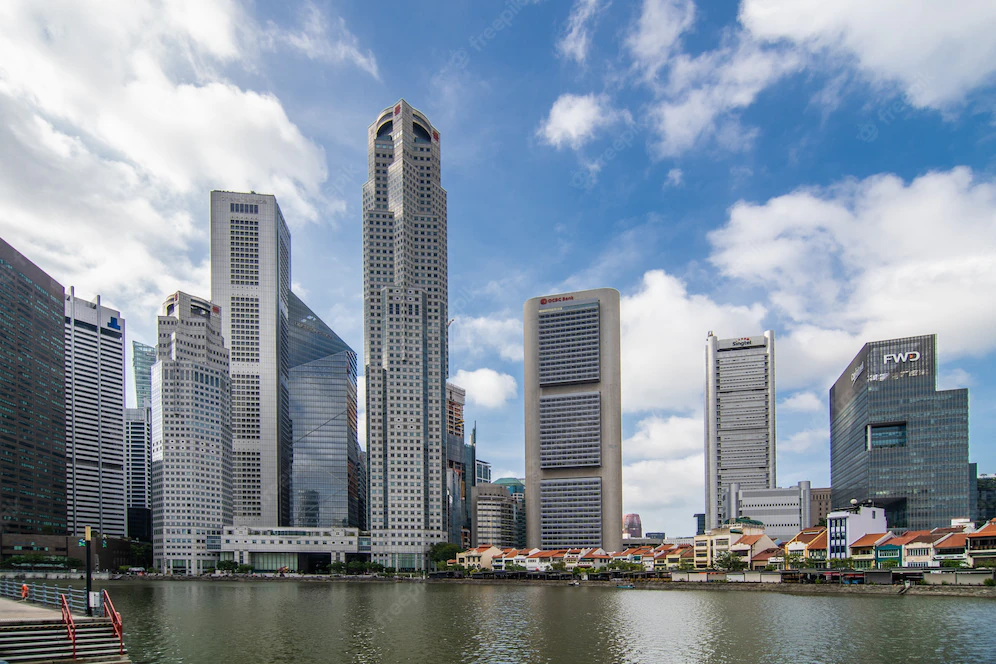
106, 581, 996, 664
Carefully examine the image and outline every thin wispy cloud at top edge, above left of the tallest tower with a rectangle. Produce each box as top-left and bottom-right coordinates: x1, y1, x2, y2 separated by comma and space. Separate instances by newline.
273, 2, 380, 80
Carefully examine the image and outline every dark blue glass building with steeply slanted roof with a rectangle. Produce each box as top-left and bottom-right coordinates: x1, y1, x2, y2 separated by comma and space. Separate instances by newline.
287, 293, 367, 530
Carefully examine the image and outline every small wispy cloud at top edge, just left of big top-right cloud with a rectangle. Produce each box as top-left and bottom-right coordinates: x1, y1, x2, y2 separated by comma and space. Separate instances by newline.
626, 0, 695, 79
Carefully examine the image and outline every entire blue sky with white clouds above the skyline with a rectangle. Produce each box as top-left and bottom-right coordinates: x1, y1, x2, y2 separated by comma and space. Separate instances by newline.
0, 0, 996, 535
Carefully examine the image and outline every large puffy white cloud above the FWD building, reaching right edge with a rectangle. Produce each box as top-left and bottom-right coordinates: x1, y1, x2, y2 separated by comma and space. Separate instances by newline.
709, 168, 996, 386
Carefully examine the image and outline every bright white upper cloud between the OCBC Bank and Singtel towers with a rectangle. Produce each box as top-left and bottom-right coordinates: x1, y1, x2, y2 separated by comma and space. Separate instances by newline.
621, 270, 766, 412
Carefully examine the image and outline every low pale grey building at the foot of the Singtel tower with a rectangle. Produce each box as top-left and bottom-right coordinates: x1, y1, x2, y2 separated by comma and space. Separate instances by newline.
726, 481, 812, 542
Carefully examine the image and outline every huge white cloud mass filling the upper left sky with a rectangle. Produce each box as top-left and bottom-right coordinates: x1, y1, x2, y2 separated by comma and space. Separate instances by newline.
0, 0, 354, 350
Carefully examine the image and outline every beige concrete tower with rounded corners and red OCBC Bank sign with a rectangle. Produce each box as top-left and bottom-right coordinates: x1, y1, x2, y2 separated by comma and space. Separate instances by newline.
523, 288, 622, 551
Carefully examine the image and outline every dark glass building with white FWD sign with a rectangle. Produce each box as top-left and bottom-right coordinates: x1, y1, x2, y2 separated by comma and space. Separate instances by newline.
830, 335, 972, 530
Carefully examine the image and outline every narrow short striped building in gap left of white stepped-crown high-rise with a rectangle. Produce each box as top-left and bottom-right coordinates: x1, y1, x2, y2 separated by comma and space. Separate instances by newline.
125, 408, 152, 542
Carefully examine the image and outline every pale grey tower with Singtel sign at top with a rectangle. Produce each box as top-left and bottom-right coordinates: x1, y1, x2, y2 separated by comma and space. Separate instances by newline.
705, 330, 777, 531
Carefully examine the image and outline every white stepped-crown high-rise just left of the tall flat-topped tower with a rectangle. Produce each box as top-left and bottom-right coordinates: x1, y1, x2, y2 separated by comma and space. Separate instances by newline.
151, 293, 232, 574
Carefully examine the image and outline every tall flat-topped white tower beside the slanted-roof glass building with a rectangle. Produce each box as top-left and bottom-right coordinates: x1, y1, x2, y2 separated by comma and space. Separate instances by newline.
211, 191, 292, 526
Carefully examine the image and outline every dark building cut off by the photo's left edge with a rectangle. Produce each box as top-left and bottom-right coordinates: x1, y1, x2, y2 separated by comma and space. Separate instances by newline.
0, 239, 66, 535
